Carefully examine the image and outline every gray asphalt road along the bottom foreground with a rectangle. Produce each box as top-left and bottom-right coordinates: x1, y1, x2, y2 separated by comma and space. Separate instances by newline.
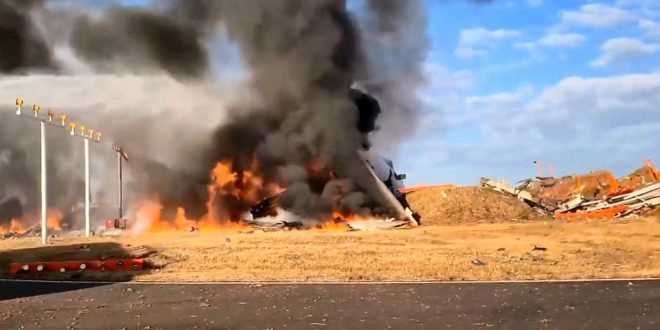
0, 281, 660, 330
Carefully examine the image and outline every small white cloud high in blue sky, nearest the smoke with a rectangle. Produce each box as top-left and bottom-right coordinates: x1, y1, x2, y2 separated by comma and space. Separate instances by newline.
454, 28, 520, 59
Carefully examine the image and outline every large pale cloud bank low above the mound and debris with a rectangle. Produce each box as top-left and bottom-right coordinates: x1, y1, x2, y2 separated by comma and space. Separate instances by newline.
415, 73, 660, 182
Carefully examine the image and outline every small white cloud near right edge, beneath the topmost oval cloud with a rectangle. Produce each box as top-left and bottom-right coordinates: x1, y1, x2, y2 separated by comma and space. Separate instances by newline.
590, 38, 660, 67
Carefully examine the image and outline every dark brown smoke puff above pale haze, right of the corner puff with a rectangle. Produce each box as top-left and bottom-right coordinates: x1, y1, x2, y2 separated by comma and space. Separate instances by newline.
71, 7, 209, 78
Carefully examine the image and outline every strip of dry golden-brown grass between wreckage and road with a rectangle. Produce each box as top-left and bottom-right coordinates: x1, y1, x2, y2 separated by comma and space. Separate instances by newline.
0, 219, 660, 281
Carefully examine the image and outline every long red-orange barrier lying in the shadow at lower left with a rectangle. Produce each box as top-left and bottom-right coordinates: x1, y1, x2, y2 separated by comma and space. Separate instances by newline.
9, 259, 145, 274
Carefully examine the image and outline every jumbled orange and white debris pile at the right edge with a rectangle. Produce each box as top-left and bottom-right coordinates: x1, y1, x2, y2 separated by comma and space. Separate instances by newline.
481, 160, 660, 219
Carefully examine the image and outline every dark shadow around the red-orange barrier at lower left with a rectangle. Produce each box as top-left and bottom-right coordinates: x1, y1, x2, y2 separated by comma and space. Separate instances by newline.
0, 242, 154, 301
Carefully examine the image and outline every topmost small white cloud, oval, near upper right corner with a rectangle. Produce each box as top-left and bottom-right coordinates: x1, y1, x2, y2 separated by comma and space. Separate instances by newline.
562, 3, 636, 28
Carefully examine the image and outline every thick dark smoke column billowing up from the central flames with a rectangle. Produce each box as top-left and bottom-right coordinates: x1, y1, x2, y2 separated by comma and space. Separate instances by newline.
193, 0, 362, 220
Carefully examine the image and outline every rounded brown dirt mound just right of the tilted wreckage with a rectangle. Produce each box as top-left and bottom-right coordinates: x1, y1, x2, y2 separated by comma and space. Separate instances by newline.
408, 187, 545, 224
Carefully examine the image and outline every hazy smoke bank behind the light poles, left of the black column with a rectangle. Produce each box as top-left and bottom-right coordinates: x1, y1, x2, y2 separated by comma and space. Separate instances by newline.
0, 0, 224, 224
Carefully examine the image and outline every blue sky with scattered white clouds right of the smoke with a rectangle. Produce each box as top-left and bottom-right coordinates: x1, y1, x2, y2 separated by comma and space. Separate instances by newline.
120, 0, 660, 184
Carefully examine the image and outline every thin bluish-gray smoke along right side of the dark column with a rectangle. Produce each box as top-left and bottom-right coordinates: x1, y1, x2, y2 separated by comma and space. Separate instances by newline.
362, 0, 430, 152
